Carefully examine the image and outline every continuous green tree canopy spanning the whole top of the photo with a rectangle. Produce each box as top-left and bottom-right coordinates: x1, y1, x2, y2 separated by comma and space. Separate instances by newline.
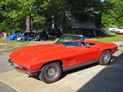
0, 0, 123, 31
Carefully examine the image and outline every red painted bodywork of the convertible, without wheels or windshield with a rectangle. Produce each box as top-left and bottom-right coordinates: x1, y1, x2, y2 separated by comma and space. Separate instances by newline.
9, 41, 117, 75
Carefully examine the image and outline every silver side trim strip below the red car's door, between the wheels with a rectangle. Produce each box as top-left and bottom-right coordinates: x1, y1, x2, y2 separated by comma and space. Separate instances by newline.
63, 59, 99, 72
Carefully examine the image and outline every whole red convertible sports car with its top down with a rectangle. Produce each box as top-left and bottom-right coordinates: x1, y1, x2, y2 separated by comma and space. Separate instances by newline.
9, 34, 117, 83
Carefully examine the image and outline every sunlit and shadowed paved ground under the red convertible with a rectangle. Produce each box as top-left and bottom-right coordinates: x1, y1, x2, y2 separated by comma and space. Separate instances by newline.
0, 42, 123, 92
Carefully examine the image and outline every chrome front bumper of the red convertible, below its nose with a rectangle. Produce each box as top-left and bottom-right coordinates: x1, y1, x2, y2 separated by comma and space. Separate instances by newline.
8, 59, 39, 75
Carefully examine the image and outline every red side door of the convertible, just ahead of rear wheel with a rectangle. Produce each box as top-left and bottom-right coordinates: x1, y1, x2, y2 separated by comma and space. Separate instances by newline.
78, 45, 100, 64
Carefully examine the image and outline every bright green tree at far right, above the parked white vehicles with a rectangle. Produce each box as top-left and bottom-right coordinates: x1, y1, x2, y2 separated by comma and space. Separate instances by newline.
102, 0, 123, 28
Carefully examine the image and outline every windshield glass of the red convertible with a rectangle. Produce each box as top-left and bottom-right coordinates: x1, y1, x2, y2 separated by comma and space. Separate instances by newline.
55, 35, 82, 46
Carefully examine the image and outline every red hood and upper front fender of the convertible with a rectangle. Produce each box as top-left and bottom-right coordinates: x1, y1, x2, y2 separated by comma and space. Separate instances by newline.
9, 44, 77, 66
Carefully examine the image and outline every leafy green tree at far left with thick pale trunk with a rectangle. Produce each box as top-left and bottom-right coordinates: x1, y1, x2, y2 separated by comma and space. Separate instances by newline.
0, 0, 36, 31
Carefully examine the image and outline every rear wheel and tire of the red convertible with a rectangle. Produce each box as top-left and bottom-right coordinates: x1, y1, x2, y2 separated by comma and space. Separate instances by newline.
99, 50, 111, 65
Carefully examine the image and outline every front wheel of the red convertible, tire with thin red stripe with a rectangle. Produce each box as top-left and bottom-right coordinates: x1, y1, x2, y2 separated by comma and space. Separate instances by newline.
39, 62, 62, 83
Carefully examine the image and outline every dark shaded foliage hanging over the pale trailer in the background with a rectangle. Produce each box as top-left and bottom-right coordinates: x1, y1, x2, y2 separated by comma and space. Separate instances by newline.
68, 0, 103, 22
